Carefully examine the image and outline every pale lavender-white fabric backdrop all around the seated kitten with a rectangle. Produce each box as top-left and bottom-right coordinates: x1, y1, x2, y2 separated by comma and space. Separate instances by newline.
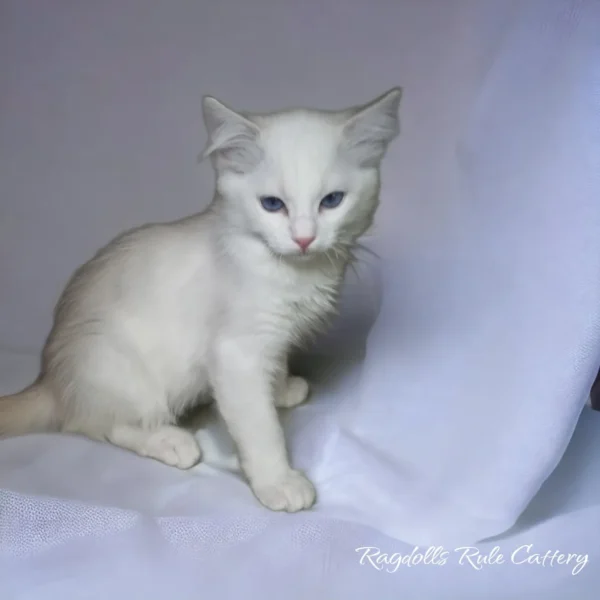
0, 0, 600, 600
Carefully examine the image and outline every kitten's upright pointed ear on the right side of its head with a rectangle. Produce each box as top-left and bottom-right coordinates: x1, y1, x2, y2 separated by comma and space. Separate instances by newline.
342, 87, 402, 167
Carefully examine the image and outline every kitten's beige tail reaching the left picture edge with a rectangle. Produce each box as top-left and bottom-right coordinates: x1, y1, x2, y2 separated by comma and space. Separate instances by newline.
0, 382, 60, 437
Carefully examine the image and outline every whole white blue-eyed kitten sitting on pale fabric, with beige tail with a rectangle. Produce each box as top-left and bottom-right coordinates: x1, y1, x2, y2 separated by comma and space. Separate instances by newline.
0, 88, 401, 511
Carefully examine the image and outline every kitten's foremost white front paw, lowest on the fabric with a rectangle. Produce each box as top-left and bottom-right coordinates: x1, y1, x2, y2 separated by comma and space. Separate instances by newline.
252, 469, 316, 512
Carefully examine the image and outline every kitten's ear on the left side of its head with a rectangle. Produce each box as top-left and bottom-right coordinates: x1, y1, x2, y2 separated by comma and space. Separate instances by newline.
200, 96, 262, 173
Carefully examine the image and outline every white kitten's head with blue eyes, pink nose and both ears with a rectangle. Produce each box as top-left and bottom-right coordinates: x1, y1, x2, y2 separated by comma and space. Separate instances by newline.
203, 88, 401, 258
